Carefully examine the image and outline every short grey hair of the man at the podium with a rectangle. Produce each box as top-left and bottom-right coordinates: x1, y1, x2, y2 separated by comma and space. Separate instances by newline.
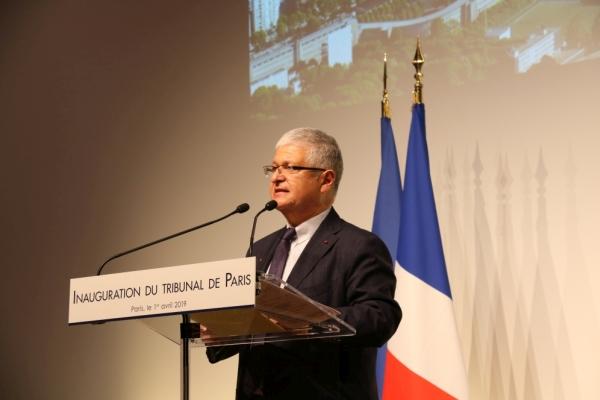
275, 128, 344, 192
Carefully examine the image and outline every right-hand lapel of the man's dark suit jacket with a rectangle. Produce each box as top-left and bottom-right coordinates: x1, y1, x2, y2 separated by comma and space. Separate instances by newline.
287, 209, 341, 288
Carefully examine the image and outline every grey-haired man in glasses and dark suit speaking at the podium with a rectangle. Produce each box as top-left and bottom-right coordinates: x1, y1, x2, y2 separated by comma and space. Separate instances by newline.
207, 128, 401, 400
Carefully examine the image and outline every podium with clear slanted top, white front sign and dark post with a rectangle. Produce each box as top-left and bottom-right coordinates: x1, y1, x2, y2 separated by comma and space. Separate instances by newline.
69, 257, 356, 400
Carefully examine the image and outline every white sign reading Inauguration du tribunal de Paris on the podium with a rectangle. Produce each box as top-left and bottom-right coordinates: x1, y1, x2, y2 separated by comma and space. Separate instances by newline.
69, 257, 256, 325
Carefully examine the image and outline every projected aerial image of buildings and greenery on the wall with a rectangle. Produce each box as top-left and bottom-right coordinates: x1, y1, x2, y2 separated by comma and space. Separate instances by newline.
249, 0, 600, 115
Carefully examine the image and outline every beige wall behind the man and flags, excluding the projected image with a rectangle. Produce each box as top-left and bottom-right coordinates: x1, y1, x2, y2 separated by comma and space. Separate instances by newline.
0, 1, 600, 400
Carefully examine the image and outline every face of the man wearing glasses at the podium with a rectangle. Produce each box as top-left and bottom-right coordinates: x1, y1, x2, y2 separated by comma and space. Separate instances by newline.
269, 144, 331, 226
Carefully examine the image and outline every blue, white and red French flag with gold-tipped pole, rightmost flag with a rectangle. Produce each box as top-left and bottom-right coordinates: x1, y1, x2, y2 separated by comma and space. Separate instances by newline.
392, 40, 469, 400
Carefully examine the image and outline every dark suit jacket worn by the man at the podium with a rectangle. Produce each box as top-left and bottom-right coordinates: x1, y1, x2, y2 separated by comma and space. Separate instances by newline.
207, 209, 401, 400
